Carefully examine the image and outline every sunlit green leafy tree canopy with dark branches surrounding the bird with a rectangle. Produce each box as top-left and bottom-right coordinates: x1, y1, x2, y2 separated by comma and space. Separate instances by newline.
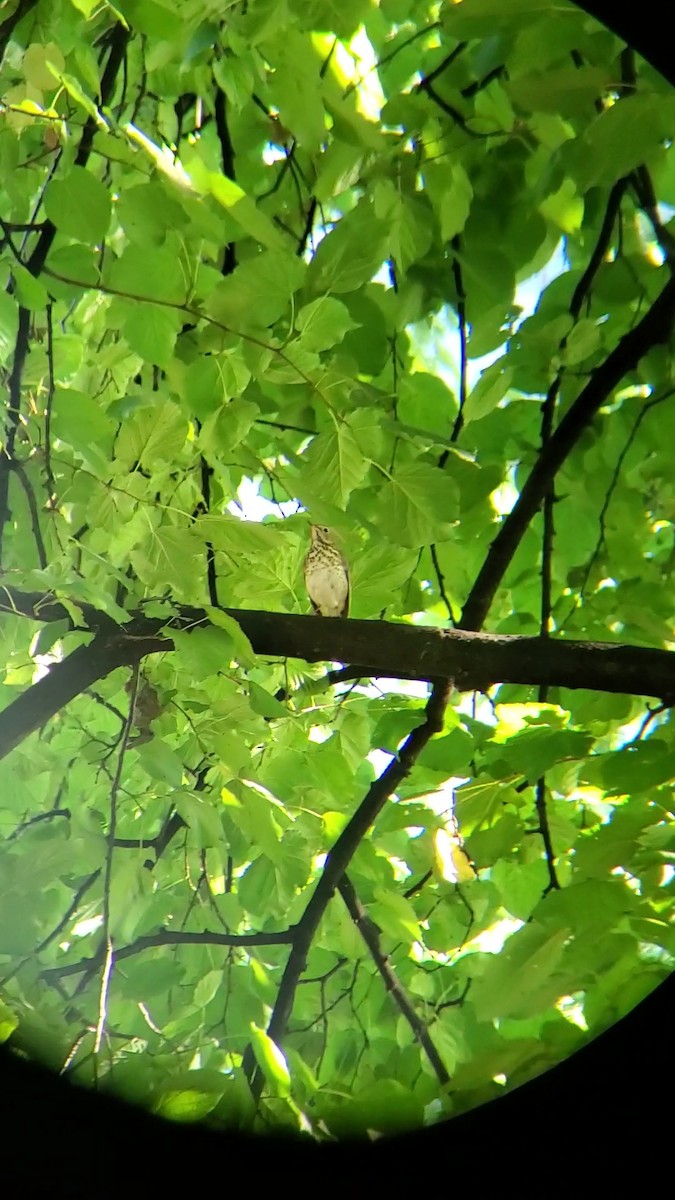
0, 0, 675, 1139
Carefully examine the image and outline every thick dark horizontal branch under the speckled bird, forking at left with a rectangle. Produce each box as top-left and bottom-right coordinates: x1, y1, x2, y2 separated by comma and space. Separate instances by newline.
0, 588, 675, 758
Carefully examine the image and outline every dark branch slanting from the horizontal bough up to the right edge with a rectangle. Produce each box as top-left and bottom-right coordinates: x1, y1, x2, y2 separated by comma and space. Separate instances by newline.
460, 272, 675, 629
